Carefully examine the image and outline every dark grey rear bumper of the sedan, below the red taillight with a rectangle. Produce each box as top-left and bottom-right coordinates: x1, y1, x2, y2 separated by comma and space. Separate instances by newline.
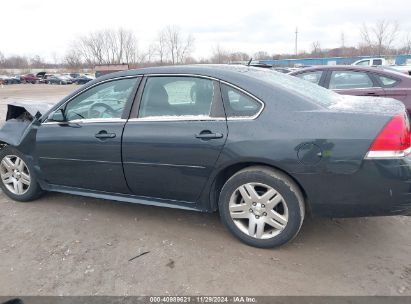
296, 155, 411, 217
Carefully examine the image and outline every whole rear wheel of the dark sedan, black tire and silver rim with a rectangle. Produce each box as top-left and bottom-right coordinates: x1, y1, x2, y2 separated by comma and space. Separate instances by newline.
219, 166, 305, 248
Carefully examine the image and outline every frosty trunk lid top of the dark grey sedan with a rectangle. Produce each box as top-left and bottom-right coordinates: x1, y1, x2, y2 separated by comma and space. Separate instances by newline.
328, 95, 405, 116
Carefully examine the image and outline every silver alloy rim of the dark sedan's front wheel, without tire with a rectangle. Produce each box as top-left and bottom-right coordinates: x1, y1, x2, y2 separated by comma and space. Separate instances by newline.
0, 155, 31, 195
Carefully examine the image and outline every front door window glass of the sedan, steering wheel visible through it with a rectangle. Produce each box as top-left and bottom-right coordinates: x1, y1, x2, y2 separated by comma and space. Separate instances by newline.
63, 78, 140, 121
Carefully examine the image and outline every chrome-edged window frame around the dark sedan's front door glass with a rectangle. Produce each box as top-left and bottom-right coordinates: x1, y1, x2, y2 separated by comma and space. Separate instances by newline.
42, 75, 144, 125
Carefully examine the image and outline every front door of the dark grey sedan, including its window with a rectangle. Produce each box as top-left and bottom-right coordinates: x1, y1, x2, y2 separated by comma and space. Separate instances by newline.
36, 77, 140, 193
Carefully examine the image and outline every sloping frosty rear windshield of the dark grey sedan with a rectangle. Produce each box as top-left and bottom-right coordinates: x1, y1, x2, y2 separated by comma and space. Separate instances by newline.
247, 69, 341, 107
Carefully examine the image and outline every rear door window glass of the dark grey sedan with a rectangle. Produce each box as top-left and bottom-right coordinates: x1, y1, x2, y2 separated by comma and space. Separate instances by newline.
139, 76, 215, 118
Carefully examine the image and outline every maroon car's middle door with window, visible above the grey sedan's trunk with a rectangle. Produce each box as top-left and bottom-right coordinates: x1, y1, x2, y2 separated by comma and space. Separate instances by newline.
326, 70, 385, 96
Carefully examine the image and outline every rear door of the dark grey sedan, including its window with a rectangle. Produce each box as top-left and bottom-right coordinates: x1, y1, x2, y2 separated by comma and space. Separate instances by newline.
123, 75, 227, 203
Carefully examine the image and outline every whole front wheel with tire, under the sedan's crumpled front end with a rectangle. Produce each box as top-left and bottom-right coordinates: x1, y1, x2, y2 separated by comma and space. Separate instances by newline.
0, 146, 43, 202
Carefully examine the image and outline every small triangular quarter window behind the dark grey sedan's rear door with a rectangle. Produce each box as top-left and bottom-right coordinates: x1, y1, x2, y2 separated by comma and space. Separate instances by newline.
221, 84, 263, 118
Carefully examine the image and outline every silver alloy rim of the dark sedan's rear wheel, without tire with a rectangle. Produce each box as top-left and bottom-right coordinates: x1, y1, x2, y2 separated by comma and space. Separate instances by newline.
229, 183, 288, 239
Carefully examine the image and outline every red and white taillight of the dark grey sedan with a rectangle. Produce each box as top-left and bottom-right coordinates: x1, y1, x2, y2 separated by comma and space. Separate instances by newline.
366, 114, 411, 158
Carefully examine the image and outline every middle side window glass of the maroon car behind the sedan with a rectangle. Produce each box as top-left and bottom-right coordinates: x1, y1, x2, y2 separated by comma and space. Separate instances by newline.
329, 71, 374, 90
